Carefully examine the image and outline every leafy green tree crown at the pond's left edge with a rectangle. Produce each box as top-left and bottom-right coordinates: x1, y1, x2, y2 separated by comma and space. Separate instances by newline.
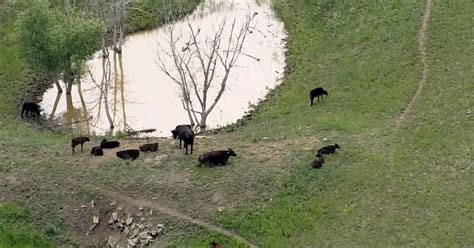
17, 1, 103, 94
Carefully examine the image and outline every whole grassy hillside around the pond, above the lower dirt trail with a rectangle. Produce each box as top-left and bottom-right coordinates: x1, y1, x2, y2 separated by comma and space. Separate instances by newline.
0, 0, 474, 247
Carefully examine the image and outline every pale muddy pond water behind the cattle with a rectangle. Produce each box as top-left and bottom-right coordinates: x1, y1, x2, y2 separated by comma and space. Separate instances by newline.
41, 0, 285, 136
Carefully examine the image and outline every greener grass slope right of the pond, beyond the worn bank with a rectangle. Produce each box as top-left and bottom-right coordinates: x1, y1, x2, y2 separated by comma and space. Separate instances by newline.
214, 1, 474, 247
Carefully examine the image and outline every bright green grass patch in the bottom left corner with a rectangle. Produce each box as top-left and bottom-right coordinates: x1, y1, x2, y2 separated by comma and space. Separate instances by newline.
0, 203, 52, 248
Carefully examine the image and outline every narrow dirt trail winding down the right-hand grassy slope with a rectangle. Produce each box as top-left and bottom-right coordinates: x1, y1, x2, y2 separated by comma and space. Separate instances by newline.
394, 0, 434, 128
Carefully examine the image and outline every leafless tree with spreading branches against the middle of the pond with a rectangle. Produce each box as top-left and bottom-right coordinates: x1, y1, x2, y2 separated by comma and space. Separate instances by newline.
157, 12, 257, 131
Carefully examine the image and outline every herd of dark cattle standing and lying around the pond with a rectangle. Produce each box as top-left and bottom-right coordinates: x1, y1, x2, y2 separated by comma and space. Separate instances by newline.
21, 87, 341, 169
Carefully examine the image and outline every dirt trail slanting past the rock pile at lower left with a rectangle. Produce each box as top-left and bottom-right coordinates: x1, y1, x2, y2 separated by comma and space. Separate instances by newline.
82, 185, 257, 248
